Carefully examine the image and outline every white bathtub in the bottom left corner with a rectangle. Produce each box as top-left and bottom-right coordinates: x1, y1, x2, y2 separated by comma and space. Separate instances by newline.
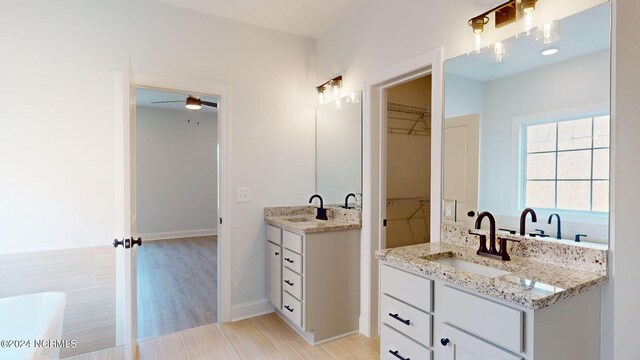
0, 292, 67, 360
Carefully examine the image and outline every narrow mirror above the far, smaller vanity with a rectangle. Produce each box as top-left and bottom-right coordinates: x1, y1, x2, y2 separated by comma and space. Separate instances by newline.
316, 92, 362, 205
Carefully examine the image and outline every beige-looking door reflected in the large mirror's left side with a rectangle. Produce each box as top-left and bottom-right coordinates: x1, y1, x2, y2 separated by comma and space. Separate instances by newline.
443, 114, 480, 223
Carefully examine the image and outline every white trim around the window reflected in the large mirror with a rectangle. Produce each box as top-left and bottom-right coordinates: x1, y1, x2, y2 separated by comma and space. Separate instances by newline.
509, 101, 611, 225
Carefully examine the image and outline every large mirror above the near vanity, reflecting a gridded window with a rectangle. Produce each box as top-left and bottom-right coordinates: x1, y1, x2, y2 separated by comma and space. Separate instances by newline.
443, 2, 611, 244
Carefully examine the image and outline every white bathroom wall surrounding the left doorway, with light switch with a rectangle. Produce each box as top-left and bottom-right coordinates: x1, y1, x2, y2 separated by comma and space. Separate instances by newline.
0, 0, 317, 310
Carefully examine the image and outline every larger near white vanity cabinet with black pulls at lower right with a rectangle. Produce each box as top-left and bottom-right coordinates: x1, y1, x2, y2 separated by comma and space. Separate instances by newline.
380, 264, 601, 360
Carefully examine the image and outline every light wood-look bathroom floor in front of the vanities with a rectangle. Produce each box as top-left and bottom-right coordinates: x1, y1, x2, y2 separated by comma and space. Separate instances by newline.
64, 313, 380, 360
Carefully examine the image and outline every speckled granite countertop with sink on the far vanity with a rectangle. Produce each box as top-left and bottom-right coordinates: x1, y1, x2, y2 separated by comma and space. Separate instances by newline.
265, 206, 362, 235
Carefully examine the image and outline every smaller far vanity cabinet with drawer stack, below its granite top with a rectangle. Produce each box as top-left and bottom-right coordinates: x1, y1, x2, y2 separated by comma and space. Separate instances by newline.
267, 225, 360, 345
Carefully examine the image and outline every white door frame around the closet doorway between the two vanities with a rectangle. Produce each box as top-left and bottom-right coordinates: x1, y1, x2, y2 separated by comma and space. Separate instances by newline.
360, 47, 443, 337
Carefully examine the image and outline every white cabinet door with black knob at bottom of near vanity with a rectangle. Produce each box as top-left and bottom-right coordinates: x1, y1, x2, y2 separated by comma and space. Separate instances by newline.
437, 324, 522, 360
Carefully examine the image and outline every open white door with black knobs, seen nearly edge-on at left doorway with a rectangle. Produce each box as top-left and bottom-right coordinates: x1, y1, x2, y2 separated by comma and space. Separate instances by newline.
114, 63, 142, 360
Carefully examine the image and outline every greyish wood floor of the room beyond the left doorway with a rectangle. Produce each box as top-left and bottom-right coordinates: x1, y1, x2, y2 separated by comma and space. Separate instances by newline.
137, 236, 218, 339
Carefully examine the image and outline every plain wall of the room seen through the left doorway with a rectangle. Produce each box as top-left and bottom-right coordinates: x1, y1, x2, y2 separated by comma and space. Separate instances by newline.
136, 106, 218, 240
